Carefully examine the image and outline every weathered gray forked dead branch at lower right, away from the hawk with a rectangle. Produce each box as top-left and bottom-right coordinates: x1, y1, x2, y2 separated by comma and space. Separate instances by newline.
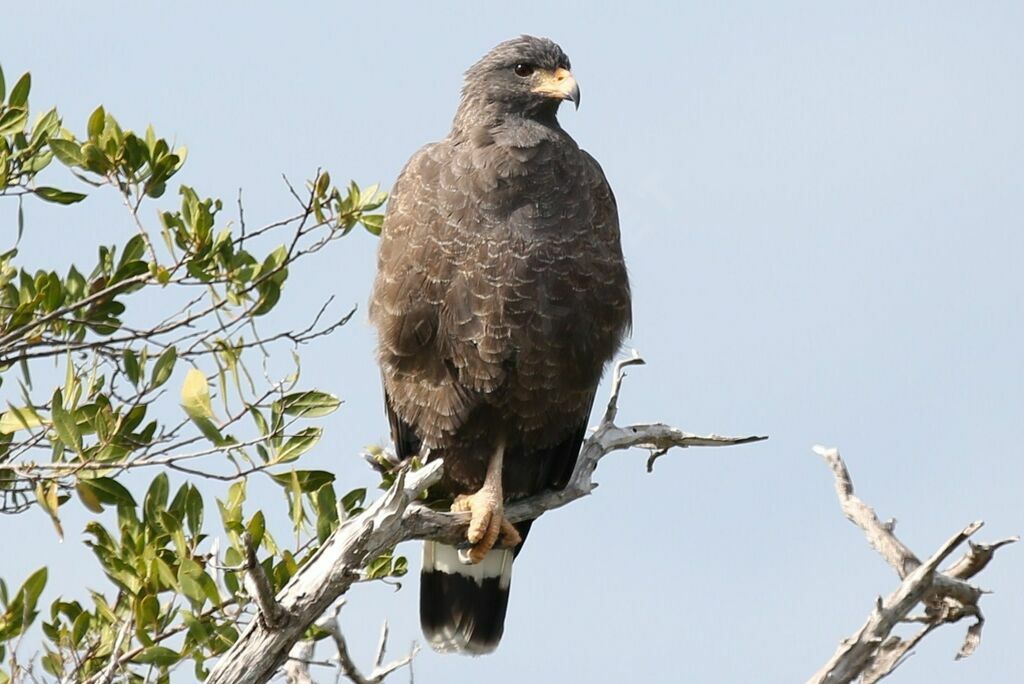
808, 446, 1018, 684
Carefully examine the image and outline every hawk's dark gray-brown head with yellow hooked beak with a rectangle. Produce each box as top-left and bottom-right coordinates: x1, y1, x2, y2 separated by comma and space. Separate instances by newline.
462, 36, 580, 117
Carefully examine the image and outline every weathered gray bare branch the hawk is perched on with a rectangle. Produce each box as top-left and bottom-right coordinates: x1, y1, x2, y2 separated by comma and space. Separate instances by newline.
207, 353, 766, 684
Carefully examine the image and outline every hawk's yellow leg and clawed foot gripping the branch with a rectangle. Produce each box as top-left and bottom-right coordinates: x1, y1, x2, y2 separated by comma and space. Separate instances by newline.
452, 441, 522, 563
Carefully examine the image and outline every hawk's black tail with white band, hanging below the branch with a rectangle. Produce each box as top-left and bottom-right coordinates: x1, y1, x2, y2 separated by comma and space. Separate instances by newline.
420, 542, 515, 655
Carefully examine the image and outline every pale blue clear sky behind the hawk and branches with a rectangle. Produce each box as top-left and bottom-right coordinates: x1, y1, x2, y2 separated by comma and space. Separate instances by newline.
0, 0, 1024, 684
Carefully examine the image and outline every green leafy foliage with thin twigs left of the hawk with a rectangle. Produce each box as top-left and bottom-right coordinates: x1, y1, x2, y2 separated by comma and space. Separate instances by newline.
0, 65, 406, 684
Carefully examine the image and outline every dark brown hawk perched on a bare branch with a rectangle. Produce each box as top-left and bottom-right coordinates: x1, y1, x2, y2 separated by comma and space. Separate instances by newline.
370, 36, 630, 653
